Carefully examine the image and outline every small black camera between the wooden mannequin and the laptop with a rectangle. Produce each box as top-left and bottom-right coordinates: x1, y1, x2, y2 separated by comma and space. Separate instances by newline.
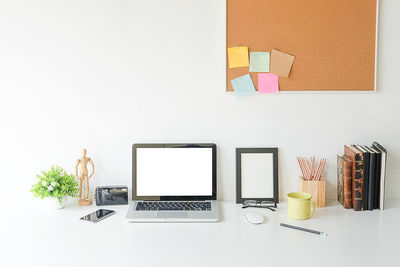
95, 186, 128, 206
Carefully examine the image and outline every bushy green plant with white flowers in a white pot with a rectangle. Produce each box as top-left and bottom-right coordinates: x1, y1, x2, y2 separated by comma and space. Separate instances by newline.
31, 166, 79, 209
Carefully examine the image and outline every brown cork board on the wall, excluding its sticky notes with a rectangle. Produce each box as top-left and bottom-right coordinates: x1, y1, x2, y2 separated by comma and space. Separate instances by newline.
226, 0, 379, 91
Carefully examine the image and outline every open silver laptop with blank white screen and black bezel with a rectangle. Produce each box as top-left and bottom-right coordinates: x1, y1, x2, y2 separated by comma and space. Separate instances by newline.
126, 144, 219, 222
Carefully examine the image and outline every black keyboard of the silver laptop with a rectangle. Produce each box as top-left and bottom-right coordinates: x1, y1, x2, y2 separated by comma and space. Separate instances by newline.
136, 201, 211, 211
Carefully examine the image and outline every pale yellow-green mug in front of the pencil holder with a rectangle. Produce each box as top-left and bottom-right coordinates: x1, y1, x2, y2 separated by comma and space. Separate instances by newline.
287, 192, 317, 220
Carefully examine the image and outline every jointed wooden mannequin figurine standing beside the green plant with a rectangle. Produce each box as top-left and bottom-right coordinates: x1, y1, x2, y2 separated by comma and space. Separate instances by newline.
75, 148, 94, 206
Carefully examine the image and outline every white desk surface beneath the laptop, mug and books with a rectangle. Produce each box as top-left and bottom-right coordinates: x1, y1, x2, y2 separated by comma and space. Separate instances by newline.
0, 202, 400, 267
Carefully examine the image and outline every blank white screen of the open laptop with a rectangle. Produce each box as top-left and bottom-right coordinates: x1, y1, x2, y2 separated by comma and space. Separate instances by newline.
136, 148, 212, 196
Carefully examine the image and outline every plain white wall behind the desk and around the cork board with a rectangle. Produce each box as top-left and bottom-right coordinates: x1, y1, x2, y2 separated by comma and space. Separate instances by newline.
0, 0, 400, 203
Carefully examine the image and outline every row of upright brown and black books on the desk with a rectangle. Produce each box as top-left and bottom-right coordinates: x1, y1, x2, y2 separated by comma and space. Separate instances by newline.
337, 142, 387, 211
